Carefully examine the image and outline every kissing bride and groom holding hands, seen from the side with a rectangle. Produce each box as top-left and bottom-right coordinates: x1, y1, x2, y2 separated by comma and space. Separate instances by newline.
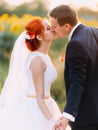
0, 5, 98, 130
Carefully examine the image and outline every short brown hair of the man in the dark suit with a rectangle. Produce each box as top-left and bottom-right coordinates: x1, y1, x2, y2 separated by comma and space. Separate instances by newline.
49, 4, 78, 26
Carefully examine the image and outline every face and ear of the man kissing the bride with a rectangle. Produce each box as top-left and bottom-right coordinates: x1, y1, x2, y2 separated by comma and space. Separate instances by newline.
50, 17, 68, 38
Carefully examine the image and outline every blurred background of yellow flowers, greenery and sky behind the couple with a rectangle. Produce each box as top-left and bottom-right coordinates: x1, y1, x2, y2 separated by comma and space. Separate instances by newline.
0, 0, 98, 110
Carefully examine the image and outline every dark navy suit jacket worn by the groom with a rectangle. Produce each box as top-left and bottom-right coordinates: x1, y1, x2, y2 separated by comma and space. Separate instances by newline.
64, 24, 98, 125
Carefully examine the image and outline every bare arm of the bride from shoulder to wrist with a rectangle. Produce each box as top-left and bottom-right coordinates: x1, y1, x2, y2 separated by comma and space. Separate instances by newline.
30, 56, 53, 120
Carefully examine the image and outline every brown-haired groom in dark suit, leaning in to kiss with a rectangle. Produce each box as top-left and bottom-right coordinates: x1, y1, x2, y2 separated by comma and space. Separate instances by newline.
49, 5, 98, 130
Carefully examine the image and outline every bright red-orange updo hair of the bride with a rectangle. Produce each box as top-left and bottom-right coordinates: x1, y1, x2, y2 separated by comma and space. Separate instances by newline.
25, 18, 44, 51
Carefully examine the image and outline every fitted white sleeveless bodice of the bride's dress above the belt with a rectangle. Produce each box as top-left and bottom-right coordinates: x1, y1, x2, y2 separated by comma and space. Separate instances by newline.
27, 52, 57, 96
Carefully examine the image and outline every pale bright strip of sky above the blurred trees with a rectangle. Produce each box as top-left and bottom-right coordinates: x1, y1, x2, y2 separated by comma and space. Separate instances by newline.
5, 0, 98, 10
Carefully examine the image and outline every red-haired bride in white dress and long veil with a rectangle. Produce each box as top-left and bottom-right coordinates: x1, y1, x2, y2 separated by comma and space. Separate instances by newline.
0, 18, 69, 130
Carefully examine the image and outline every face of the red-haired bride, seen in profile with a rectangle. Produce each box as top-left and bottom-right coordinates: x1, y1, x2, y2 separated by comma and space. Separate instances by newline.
42, 20, 56, 41
